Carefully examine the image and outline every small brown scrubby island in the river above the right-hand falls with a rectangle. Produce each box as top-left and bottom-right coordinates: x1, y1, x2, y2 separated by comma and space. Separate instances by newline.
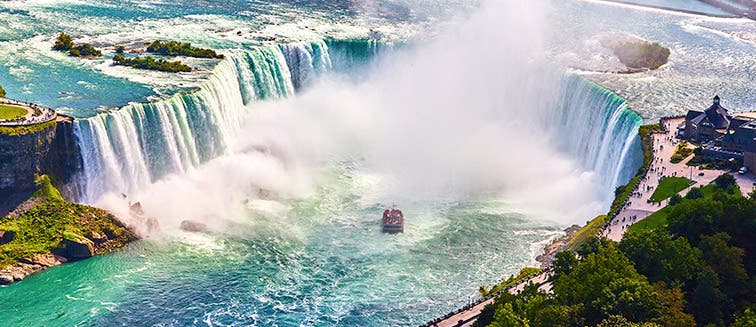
602, 35, 670, 72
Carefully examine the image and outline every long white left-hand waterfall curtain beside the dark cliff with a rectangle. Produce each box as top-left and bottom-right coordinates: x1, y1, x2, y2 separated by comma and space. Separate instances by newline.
74, 40, 344, 203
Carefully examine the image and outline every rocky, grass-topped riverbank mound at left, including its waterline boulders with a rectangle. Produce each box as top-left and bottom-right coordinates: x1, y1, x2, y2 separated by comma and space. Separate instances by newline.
0, 175, 137, 285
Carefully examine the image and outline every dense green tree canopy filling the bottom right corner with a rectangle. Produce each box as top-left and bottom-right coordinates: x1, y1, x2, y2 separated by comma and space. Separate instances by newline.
476, 186, 756, 327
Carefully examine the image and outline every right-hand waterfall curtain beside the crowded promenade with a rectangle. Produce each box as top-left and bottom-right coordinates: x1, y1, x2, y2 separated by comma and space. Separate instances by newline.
546, 75, 643, 200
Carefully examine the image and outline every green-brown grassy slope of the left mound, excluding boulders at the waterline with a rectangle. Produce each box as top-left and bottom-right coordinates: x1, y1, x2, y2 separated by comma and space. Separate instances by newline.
0, 175, 136, 269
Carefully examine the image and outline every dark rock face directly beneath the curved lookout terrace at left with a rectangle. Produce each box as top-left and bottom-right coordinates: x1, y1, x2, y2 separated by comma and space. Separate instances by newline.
0, 124, 55, 194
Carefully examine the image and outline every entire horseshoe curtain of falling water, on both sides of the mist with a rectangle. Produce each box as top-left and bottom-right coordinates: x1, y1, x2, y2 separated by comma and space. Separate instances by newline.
72, 40, 642, 203
